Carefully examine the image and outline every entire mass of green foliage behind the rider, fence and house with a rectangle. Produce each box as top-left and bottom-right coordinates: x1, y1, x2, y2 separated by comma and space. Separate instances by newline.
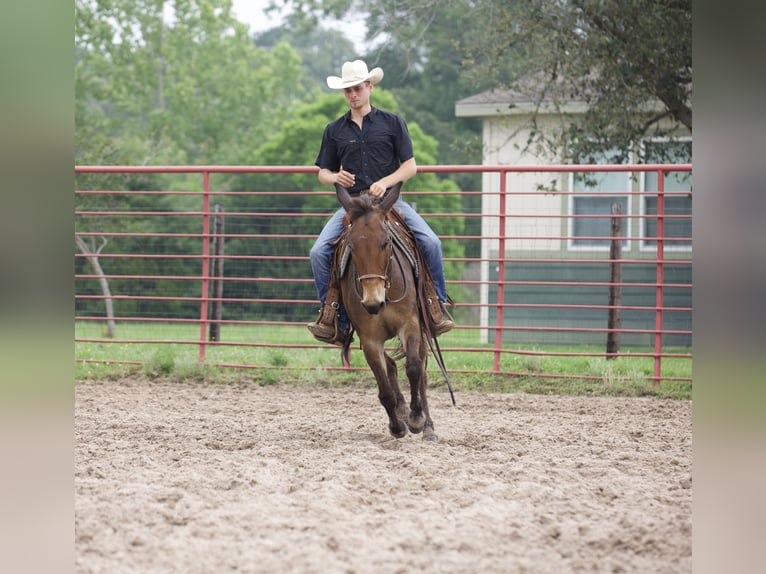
75, 0, 691, 328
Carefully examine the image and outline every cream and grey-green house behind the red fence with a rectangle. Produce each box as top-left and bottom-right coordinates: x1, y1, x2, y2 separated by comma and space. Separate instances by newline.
455, 90, 692, 346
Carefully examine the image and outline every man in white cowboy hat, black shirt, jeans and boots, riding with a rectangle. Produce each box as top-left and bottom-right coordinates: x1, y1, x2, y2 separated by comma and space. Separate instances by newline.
307, 60, 454, 345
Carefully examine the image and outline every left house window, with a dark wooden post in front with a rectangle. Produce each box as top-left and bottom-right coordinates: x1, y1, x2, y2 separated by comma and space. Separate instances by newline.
569, 154, 630, 250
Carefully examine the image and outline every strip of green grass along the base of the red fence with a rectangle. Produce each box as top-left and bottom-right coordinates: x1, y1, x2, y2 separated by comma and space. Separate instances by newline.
75, 322, 692, 400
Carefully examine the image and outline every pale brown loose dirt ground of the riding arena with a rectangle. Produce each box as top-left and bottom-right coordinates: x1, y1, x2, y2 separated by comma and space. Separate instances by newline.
75, 379, 692, 574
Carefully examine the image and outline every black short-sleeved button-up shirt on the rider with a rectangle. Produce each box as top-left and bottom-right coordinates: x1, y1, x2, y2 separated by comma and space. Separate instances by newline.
315, 108, 413, 194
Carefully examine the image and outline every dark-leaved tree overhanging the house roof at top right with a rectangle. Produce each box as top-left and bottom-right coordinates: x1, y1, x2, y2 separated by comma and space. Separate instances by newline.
470, 0, 692, 162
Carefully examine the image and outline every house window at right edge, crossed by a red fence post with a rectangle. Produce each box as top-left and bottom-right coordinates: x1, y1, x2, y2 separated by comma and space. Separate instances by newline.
641, 140, 692, 251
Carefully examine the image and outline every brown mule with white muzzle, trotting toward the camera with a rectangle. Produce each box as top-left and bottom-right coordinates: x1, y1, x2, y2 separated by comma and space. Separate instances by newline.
335, 183, 438, 441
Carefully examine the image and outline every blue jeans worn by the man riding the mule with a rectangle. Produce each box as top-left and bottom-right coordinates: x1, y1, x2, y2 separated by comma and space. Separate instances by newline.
309, 198, 447, 326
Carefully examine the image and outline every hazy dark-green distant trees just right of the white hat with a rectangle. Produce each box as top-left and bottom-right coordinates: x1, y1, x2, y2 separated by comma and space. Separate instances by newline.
273, 0, 490, 177
